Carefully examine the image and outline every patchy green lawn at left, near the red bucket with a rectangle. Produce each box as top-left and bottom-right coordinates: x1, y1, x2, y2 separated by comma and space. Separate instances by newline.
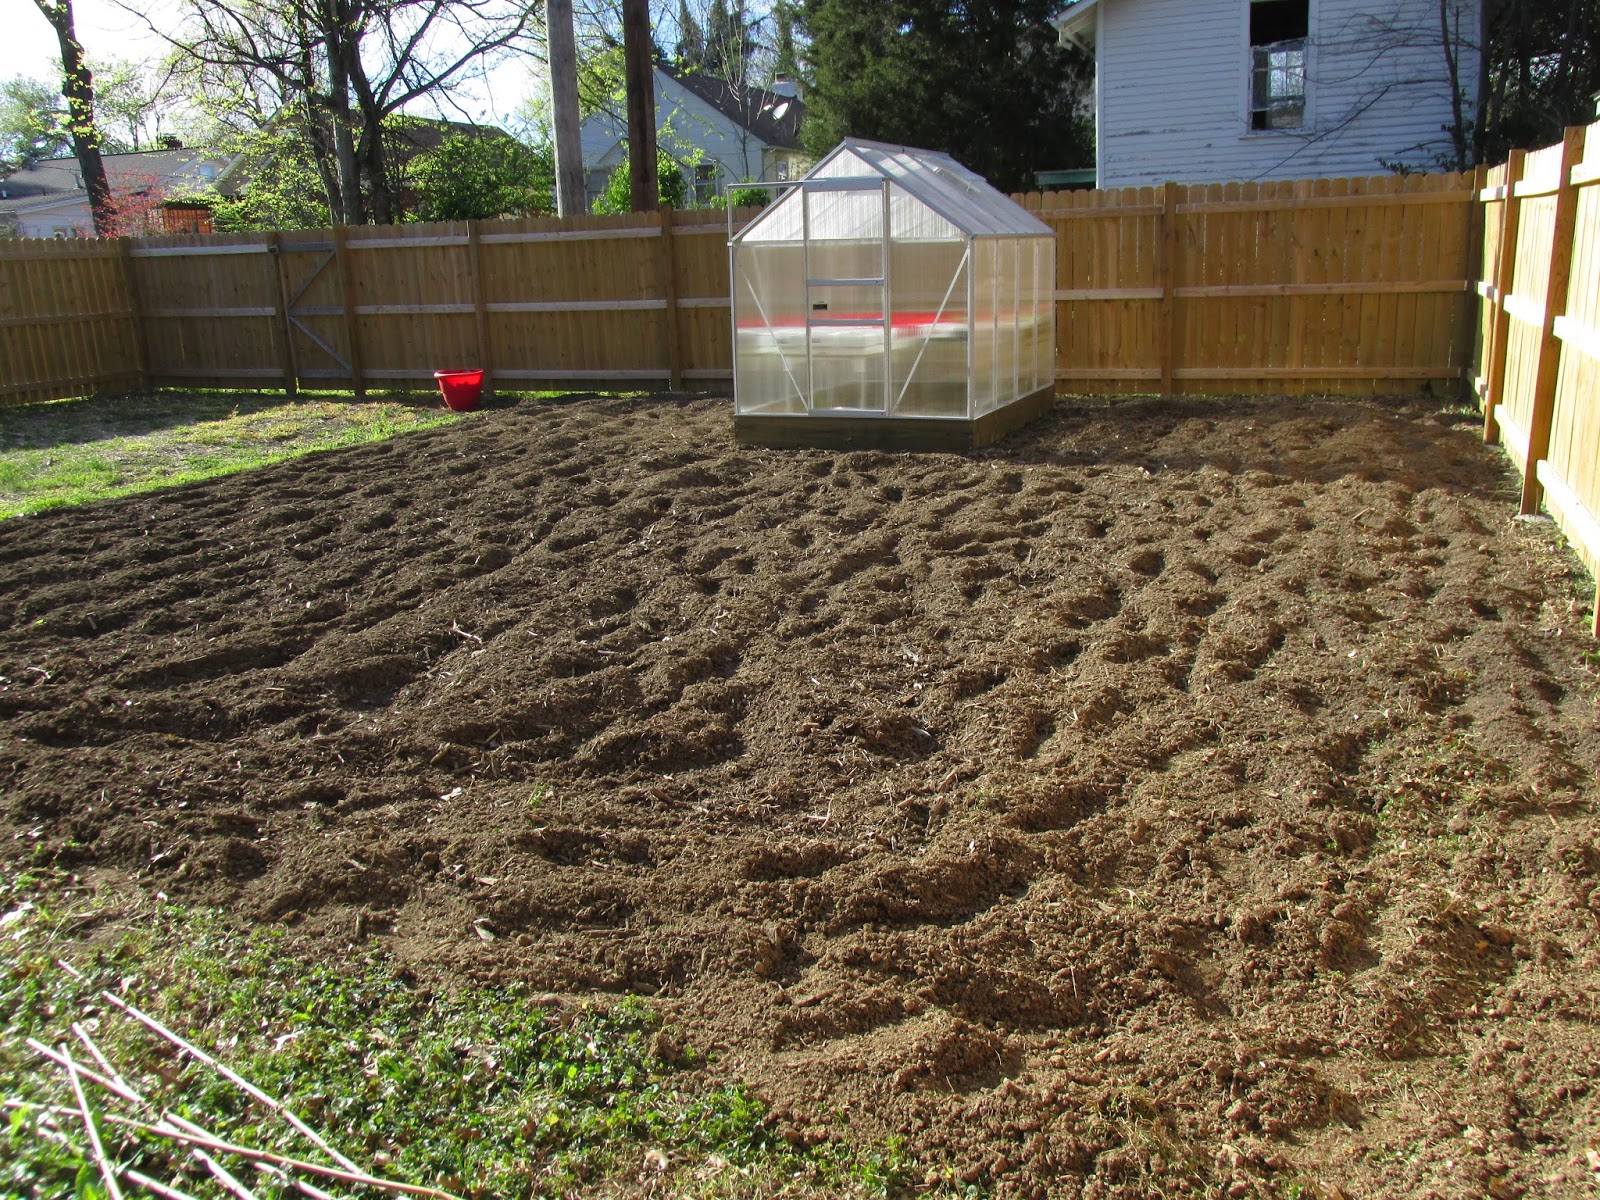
0, 390, 464, 518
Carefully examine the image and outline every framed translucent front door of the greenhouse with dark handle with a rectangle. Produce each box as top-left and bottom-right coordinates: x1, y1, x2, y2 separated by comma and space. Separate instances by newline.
802, 179, 891, 414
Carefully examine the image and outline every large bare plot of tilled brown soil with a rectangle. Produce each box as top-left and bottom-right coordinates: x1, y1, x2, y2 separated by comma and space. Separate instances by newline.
0, 397, 1600, 1200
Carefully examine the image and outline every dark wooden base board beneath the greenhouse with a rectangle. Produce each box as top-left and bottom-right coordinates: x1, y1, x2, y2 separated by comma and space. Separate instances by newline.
733, 386, 1056, 453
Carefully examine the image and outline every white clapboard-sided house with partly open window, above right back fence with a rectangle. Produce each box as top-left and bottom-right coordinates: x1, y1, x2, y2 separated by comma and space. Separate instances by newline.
1051, 0, 1478, 187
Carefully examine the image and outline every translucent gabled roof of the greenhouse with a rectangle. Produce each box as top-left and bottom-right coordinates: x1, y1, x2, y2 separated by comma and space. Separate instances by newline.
734, 138, 1054, 240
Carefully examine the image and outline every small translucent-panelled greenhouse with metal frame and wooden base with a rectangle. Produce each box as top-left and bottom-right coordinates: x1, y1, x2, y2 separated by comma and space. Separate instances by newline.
731, 139, 1056, 450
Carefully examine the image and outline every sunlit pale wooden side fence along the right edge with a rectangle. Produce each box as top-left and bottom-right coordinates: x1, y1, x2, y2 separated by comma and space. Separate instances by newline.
1475, 117, 1600, 635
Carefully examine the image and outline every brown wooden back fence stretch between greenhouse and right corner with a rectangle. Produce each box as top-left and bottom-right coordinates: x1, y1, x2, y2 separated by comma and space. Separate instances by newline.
1018, 174, 1475, 394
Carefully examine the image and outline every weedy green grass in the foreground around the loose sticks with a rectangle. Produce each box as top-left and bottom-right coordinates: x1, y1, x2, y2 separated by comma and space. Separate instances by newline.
0, 875, 910, 1200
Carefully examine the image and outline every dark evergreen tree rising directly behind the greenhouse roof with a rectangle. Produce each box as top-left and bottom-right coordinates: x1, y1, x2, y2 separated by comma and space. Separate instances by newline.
798, 0, 1094, 190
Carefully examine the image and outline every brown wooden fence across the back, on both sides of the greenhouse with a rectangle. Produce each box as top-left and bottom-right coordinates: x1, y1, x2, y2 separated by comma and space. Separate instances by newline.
0, 174, 1475, 402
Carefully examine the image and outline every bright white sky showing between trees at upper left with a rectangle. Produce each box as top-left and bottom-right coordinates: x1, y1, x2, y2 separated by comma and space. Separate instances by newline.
0, 0, 544, 125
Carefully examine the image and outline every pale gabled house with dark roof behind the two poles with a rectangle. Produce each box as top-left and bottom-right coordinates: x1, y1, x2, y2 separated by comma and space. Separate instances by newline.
582, 66, 808, 205
